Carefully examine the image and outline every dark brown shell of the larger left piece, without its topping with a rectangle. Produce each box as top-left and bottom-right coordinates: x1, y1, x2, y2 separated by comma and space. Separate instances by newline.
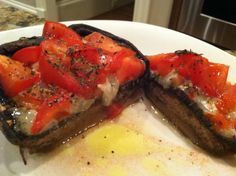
0, 24, 149, 153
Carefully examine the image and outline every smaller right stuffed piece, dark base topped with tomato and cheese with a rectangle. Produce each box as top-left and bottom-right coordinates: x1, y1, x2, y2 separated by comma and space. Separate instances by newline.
144, 50, 236, 155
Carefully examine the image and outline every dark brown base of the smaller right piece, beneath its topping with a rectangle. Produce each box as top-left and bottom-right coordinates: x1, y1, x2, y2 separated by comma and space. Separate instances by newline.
144, 72, 236, 156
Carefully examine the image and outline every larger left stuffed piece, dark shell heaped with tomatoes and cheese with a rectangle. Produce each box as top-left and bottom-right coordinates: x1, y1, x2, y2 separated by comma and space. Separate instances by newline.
0, 21, 147, 152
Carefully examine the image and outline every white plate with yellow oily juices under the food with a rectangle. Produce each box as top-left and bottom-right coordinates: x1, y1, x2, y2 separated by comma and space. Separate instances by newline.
0, 21, 236, 176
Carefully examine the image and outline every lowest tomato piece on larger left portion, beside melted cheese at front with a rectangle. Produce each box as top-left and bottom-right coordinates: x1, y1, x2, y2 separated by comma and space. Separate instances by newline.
31, 93, 71, 134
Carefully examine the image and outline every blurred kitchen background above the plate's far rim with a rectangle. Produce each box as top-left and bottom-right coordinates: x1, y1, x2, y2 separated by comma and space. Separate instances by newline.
0, 0, 236, 54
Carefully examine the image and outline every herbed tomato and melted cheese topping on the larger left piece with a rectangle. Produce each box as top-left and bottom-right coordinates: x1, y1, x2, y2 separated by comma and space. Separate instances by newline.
0, 21, 145, 135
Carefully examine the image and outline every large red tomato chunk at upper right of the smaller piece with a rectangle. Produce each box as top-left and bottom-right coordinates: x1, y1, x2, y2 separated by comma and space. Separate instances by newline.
177, 54, 228, 97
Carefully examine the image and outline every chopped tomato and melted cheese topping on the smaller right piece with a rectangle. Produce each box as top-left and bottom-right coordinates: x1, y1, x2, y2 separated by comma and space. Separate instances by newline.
148, 50, 236, 137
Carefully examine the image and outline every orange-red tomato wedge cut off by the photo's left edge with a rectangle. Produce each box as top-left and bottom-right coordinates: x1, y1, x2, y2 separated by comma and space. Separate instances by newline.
0, 56, 40, 97
